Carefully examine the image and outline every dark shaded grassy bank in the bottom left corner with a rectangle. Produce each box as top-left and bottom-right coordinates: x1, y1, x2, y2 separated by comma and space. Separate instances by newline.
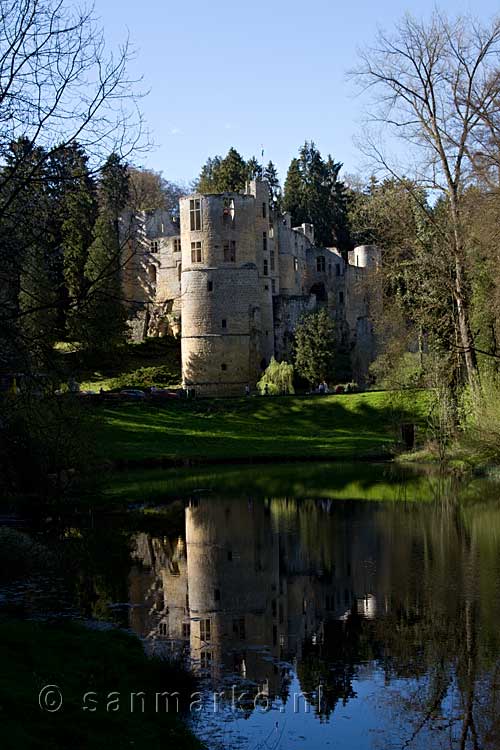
0, 620, 201, 750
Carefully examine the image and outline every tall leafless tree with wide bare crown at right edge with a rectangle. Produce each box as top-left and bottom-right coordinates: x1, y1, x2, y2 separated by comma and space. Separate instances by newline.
352, 12, 500, 386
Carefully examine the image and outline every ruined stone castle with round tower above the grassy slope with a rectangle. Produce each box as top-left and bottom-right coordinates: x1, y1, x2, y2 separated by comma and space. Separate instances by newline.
122, 180, 380, 395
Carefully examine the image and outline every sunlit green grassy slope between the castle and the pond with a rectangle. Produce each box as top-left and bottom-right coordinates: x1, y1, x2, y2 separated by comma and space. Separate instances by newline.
97, 392, 426, 468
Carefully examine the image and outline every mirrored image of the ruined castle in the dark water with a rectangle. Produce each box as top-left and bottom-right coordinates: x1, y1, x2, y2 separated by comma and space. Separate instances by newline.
130, 495, 382, 697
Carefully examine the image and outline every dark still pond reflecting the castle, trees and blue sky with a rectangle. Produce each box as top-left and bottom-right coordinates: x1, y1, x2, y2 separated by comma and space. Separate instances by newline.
0, 465, 500, 750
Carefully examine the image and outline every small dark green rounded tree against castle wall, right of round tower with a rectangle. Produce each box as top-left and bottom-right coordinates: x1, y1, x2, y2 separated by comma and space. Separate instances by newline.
295, 309, 336, 386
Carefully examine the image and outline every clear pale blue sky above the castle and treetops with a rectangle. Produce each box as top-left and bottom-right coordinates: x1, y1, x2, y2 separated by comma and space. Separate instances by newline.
95, 0, 500, 187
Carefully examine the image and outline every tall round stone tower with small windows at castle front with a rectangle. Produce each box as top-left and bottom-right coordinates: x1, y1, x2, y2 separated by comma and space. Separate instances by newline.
180, 193, 261, 395
